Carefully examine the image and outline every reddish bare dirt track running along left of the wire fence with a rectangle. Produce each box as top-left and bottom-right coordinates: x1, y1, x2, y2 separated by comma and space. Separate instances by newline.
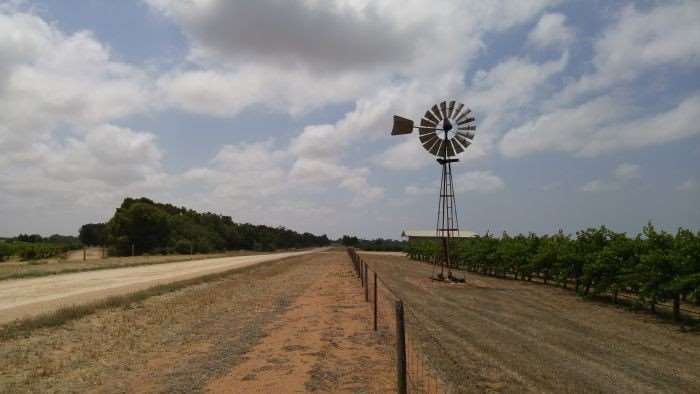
207, 255, 395, 393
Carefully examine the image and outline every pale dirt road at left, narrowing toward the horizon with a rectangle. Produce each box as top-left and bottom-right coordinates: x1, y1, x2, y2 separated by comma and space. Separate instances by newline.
0, 250, 317, 324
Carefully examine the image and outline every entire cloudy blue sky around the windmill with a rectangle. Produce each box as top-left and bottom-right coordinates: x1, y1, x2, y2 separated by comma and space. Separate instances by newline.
0, 0, 700, 238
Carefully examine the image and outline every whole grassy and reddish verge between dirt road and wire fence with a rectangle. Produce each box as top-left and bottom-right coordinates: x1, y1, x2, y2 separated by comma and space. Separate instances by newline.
0, 252, 393, 393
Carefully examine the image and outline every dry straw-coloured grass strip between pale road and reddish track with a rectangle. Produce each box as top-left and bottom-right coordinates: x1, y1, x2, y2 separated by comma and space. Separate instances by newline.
0, 256, 315, 393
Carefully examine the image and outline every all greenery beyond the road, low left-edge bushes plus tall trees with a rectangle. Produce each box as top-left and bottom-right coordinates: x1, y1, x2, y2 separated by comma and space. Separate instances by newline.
0, 198, 330, 262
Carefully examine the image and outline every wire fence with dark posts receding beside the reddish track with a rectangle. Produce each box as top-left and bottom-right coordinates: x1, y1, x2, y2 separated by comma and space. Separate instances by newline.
347, 248, 457, 394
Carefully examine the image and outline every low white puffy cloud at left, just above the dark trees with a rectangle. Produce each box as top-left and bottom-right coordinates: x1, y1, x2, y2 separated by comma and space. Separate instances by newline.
0, 124, 170, 207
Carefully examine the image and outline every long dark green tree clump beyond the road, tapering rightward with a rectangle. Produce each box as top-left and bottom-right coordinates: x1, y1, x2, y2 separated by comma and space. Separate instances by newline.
79, 198, 330, 256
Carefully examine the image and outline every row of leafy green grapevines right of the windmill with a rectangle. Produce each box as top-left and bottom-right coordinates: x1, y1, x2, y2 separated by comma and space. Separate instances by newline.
408, 223, 700, 319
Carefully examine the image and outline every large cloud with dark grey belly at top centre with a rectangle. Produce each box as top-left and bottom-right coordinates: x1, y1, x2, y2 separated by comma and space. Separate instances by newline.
147, 0, 554, 120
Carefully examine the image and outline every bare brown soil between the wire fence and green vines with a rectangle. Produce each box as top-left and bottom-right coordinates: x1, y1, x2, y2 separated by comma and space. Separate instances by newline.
362, 254, 700, 393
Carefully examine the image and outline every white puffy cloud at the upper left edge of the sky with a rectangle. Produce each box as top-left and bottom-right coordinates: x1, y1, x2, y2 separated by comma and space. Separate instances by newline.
0, 13, 149, 137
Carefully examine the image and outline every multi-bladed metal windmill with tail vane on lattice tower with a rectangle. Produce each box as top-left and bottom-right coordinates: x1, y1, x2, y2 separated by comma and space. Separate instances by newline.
391, 100, 476, 282
